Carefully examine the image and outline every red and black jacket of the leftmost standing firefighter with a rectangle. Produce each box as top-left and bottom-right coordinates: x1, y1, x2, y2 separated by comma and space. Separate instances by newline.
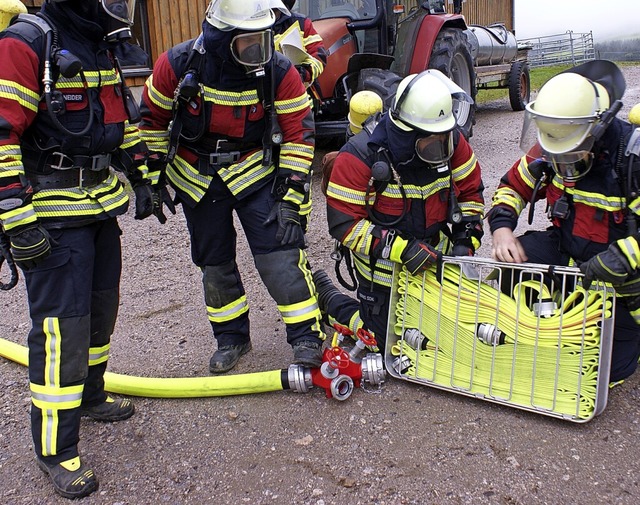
0, 3, 146, 234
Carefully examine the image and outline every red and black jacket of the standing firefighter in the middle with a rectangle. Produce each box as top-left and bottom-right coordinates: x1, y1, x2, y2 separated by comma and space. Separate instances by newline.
140, 21, 314, 211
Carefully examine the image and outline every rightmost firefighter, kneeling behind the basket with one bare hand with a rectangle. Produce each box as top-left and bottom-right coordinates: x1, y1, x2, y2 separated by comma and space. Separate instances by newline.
488, 60, 640, 383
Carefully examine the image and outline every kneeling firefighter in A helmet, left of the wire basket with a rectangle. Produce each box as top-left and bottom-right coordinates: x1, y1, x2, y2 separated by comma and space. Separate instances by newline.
314, 70, 484, 348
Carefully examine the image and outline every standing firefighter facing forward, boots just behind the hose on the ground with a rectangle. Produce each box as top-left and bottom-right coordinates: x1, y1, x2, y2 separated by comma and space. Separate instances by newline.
140, 0, 324, 373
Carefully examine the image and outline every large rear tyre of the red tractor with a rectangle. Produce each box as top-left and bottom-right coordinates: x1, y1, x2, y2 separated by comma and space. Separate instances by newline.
429, 28, 477, 138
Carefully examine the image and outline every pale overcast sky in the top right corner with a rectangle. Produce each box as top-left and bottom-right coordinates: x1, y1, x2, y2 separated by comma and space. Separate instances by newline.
515, 0, 640, 41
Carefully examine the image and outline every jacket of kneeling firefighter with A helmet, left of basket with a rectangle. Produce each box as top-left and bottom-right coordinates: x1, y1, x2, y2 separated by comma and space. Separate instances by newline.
327, 114, 484, 288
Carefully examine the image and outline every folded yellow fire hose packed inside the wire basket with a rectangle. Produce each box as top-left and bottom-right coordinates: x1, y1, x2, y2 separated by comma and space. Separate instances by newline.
391, 264, 611, 418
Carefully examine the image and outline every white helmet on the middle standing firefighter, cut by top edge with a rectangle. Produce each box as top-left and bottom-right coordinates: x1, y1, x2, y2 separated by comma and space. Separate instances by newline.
205, 0, 289, 32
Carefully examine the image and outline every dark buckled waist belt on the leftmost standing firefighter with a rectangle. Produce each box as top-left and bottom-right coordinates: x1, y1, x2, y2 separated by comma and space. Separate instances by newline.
25, 152, 111, 189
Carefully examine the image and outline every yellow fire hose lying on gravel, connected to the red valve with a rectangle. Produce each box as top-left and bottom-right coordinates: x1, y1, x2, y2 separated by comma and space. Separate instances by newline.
0, 338, 289, 398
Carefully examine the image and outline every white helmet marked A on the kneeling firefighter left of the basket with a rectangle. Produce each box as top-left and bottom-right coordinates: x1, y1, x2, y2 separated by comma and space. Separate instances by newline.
389, 69, 471, 133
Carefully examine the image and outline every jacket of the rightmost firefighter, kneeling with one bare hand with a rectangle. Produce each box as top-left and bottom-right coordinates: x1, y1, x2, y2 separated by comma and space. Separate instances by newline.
488, 118, 640, 261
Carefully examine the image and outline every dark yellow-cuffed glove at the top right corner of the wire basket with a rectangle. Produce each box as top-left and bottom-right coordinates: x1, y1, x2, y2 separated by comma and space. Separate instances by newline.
580, 237, 640, 288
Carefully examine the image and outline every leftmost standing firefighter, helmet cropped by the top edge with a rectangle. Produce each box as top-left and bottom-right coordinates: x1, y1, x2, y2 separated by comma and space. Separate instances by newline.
0, 0, 159, 498
